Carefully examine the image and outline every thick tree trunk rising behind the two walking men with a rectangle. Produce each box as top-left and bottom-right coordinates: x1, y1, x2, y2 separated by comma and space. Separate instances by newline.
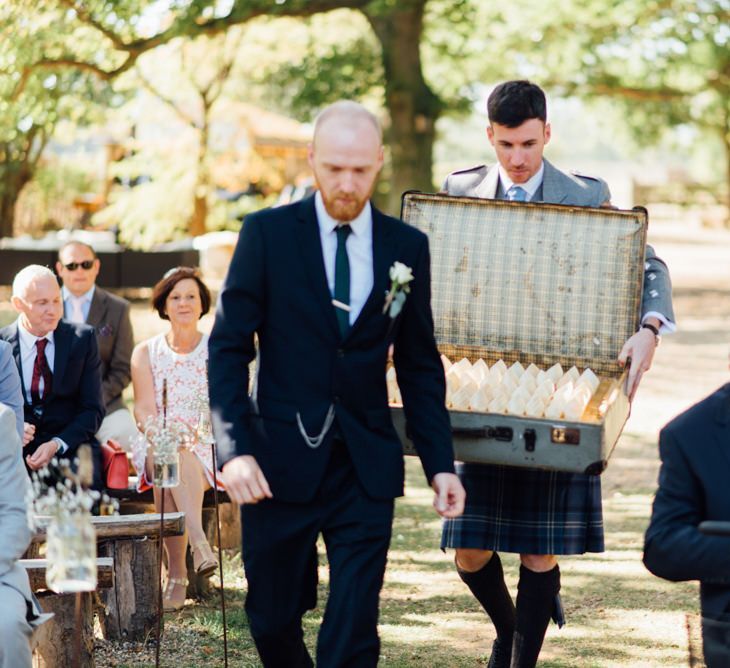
366, 0, 443, 215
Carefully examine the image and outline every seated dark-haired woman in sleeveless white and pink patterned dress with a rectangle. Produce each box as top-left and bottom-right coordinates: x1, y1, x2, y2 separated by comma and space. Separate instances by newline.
132, 267, 223, 611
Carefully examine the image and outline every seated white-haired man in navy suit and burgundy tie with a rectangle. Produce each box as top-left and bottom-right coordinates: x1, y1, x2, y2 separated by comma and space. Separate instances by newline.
0, 264, 104, 489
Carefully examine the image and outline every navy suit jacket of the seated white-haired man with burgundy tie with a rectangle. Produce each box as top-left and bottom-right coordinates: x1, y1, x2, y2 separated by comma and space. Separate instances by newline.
0, 320, 104, 486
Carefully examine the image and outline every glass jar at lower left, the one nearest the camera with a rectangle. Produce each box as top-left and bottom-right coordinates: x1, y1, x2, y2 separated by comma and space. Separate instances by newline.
46, 510, 96, 594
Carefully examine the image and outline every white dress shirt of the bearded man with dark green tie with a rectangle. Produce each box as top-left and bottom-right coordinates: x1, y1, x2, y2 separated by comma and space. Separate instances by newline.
314, 191, 373, 325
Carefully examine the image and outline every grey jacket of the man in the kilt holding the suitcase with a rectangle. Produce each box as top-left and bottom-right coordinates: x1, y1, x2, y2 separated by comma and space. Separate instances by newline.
443, 158, 675, 323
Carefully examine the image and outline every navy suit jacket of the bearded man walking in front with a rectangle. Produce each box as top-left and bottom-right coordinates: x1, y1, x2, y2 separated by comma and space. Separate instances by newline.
209, 197, 454, 502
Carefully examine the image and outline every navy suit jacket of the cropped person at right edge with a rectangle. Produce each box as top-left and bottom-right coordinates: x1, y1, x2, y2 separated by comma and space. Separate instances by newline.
644, 383, 730, 621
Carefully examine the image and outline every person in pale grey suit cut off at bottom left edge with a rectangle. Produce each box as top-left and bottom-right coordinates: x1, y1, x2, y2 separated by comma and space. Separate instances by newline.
0, 403, 49, 668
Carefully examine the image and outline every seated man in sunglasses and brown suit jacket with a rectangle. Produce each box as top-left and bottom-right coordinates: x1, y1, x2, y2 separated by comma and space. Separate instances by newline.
56, 241, 137, 452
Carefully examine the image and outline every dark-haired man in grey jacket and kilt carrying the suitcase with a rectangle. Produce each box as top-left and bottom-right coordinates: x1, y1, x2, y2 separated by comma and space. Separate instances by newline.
442, 81, 675, 668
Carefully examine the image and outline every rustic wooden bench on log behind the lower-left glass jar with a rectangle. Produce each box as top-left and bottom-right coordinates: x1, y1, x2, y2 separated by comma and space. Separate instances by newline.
25, 557, 114, 668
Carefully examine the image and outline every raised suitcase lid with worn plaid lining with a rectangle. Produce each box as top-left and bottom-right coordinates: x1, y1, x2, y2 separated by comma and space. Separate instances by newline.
401, 192, 648, 376
